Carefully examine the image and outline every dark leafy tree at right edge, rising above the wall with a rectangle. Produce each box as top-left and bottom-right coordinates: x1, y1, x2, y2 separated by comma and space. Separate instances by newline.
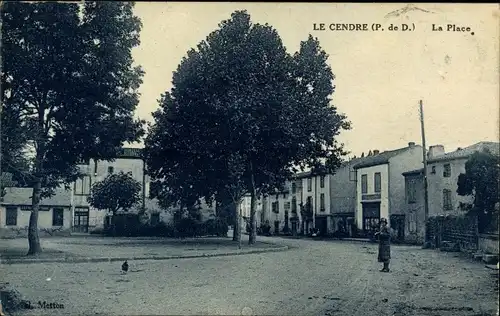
457, 150, 500, 231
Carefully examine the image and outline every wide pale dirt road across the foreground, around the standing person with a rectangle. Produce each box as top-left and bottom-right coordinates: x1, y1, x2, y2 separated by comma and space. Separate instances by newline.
0, 237, 498, 316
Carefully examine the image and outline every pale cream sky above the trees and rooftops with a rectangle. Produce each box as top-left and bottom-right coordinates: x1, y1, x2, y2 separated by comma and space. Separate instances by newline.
128, 2, 500, 156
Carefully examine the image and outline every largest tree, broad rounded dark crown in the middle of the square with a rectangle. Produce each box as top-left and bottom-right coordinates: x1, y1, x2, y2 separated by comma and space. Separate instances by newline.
146, 11, 349, 243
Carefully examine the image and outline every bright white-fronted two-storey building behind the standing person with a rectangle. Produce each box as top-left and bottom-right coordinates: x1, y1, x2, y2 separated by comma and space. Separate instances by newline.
354, 142, 423, 238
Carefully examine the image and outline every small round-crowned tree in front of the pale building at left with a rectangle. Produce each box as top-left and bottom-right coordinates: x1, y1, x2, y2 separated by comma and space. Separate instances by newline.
87, 172, 142, 215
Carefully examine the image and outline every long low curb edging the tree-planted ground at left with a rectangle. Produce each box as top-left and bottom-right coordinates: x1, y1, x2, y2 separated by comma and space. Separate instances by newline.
0, 246, 290, 265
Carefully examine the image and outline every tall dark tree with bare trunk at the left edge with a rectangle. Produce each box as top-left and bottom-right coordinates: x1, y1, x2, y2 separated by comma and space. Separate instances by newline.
1, 1, 143, 255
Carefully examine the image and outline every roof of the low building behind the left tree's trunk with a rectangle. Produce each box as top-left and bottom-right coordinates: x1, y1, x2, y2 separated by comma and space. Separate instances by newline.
2, 188, 71, 206
